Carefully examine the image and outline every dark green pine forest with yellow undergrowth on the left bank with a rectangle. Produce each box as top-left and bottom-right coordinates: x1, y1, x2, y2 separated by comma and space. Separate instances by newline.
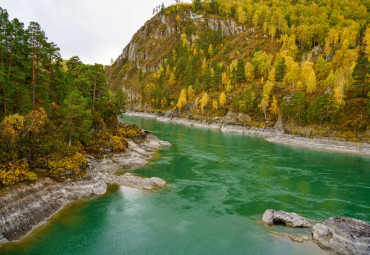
0, 8, 132, 190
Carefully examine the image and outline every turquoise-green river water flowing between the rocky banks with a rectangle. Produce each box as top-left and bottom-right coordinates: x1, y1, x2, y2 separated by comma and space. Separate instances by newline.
0, 117, 370, 255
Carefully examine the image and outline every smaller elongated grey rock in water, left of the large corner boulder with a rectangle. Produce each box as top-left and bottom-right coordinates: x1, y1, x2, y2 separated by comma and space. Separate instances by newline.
262, 209, 312, 228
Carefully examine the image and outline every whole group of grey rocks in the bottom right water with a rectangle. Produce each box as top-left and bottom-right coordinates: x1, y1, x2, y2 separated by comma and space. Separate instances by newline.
262, 209, 370, 255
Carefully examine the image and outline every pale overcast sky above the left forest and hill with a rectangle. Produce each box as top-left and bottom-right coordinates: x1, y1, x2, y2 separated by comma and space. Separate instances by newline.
0, 0, 191, 64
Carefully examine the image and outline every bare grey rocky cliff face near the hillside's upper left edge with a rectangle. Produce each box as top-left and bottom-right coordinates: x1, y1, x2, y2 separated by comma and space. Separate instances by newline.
116, 11, 244, 72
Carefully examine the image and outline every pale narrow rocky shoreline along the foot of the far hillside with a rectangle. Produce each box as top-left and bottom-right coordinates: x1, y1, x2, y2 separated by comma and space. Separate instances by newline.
126, 111, 370, 157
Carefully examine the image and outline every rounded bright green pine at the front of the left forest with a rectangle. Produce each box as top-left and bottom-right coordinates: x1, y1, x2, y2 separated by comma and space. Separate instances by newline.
62, 90, 92, 146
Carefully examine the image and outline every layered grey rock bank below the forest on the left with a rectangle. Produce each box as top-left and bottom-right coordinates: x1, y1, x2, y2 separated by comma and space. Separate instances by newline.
0, 134, 171, 245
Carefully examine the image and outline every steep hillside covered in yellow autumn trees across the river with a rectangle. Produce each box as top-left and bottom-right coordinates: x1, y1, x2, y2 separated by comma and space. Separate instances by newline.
107, 0, 370, 141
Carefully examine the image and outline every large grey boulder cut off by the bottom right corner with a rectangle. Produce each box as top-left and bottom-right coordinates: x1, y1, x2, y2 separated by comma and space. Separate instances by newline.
312, 217, 370, 255
